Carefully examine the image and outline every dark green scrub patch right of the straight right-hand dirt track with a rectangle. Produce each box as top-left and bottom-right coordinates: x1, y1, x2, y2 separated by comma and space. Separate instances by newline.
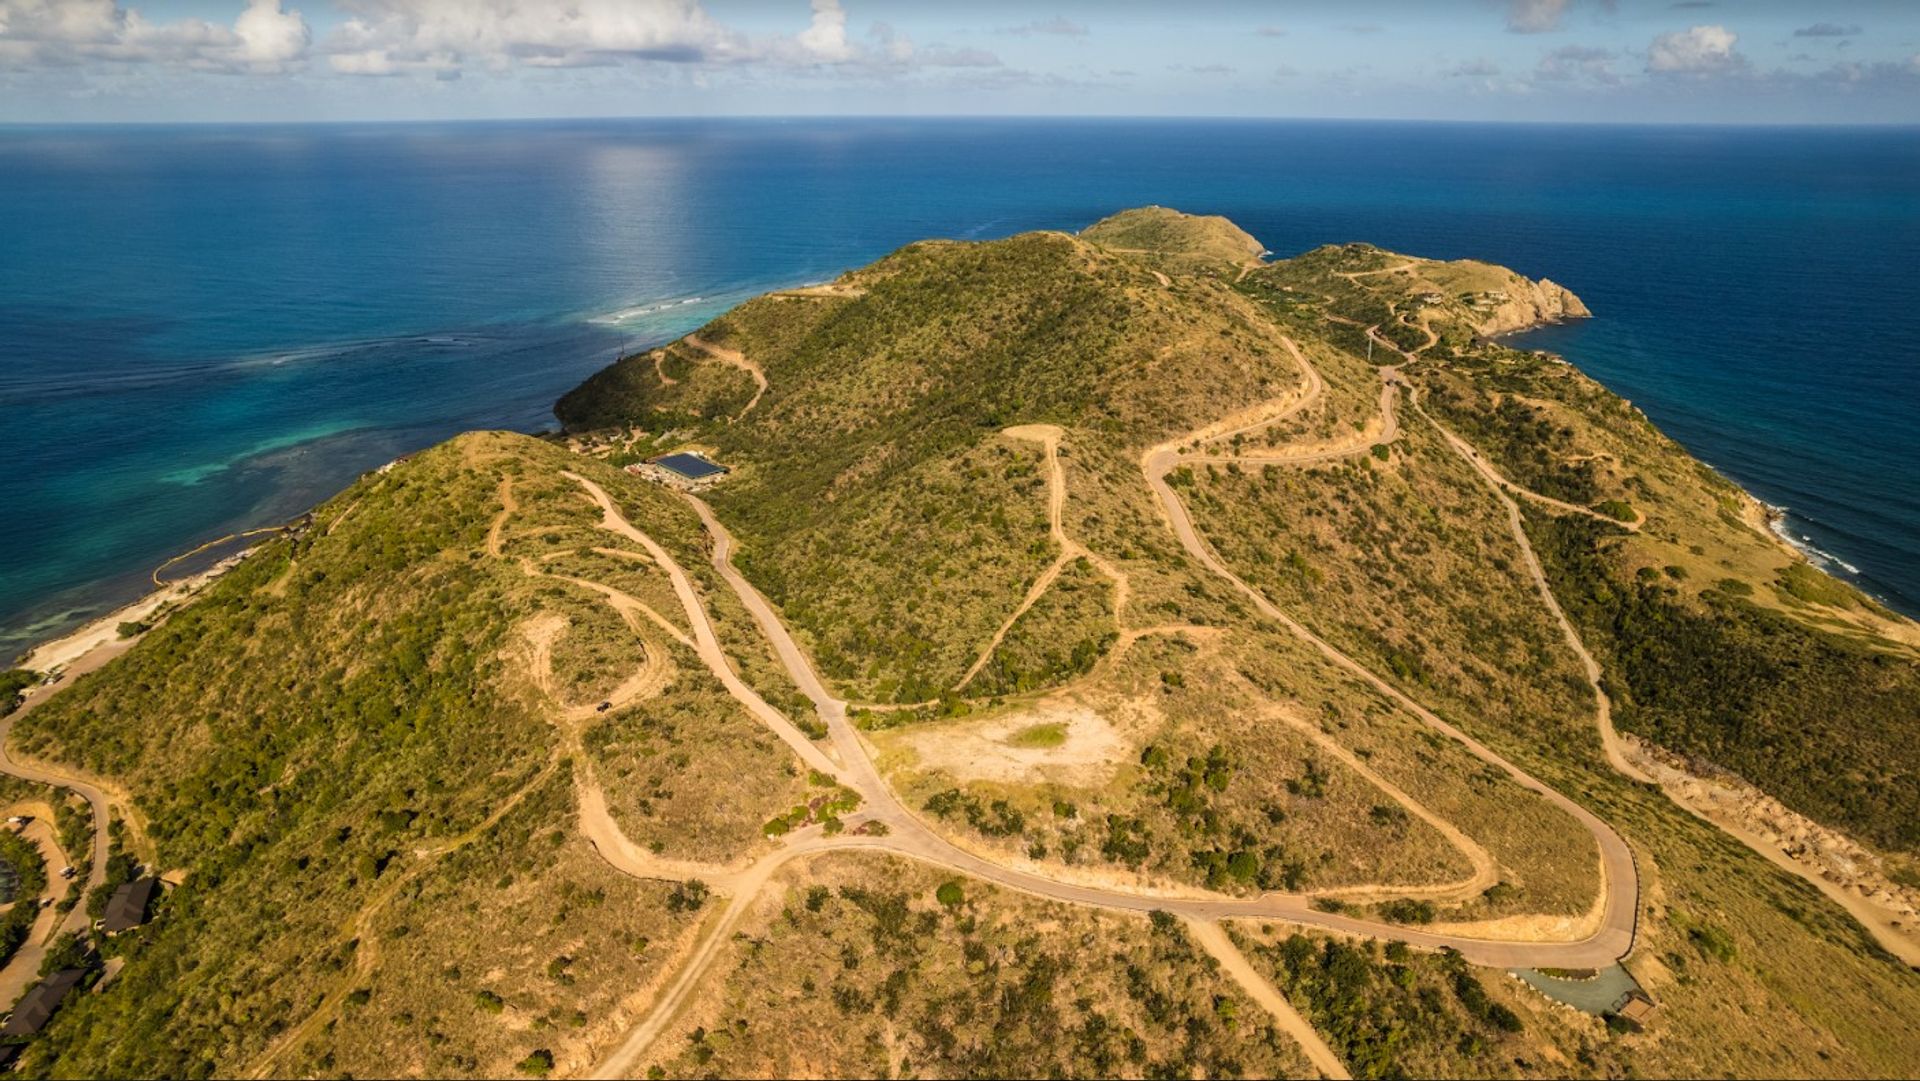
1526, 515, 1920, 853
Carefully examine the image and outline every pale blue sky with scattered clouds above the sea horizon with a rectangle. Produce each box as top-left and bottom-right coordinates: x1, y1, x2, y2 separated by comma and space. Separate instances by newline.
0, 0, 1920, 125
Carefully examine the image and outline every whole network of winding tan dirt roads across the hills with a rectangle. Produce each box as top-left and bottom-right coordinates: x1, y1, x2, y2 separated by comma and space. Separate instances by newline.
11, 251, 1891, 1077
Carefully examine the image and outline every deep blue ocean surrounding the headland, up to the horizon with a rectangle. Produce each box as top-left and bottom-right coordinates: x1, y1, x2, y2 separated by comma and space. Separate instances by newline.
0, 119, 1920, 657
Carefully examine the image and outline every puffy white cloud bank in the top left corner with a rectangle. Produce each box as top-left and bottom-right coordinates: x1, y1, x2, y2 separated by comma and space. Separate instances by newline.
0, 0, 309, 73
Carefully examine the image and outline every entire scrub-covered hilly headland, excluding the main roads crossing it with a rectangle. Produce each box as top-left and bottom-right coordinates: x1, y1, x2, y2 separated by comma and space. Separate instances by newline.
10, 207, 1920, 1077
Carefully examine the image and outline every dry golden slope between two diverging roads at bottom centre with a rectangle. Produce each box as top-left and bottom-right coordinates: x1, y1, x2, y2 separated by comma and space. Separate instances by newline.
636, 854, 1311, 1077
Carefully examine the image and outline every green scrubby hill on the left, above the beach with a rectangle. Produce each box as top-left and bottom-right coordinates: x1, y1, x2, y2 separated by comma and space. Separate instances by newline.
13, 434, 803, 1077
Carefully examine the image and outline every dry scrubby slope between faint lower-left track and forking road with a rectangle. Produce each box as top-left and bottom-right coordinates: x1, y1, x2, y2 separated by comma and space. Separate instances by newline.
286, 772, 703, 1077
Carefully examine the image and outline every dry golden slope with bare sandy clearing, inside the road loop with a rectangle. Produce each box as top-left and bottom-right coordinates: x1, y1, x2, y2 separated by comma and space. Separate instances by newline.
874, 634, 1471, 891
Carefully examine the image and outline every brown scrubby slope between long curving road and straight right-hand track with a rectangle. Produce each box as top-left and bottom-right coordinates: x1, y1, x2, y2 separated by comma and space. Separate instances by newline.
1188, 426, 1597, 753
